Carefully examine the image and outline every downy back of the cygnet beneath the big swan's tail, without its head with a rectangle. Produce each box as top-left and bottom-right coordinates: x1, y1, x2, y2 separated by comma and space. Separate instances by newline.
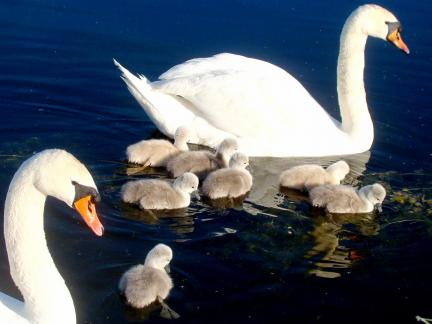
126, 139, 179, 167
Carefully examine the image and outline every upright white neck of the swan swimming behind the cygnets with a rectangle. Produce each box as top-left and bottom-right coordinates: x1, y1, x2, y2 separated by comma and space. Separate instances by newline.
337, 11, 373, 151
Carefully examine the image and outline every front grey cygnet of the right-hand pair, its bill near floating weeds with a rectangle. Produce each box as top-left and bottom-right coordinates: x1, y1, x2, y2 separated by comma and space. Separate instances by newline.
309, 183, 386, 214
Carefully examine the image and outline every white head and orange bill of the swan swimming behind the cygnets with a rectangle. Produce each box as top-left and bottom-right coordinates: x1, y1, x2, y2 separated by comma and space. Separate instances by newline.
347, 4, 409, 54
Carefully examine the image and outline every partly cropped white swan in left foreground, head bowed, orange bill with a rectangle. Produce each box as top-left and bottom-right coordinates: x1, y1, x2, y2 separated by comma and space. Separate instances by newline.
0, 150, 103, 324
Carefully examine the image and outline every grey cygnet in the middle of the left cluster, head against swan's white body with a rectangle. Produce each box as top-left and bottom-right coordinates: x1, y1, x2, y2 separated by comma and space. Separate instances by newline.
167, 138, 237, 179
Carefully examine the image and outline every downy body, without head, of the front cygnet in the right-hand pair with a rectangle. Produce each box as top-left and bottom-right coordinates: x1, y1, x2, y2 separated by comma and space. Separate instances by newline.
309, 185, 365, 213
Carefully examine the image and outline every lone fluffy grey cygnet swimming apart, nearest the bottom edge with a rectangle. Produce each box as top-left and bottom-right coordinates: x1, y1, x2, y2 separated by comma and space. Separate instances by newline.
118, 244, 173, 308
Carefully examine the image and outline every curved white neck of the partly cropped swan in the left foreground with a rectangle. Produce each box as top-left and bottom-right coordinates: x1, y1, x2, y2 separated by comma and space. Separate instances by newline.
4, 164, 76, 324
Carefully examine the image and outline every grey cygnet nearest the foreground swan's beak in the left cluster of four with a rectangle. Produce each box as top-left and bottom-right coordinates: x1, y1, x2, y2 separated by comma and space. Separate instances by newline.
121, 172, 199, 209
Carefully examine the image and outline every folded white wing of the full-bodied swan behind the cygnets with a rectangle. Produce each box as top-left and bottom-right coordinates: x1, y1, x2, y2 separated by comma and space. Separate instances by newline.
152, 54, 334, 138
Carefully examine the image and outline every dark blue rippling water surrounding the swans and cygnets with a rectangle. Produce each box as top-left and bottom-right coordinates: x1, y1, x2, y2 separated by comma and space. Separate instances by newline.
0, 0, 432, 323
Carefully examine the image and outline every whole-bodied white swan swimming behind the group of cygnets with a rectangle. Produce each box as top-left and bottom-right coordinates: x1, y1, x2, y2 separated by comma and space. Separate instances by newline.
114, 5, 409, 156
